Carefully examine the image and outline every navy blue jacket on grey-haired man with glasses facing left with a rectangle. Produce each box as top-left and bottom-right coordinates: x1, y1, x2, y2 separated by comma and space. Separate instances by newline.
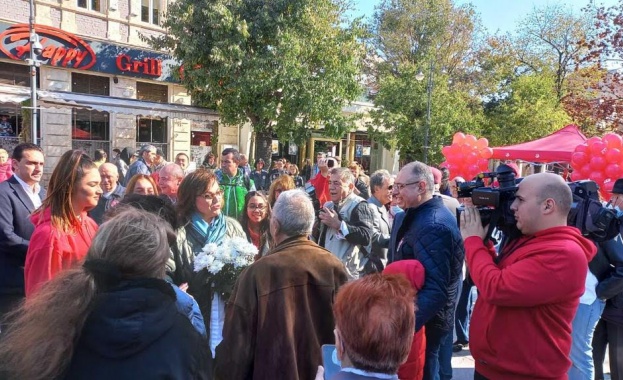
389, 197, 465, 331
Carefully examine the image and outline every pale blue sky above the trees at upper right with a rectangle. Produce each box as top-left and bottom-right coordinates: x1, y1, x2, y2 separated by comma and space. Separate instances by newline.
353, 0, 618, 33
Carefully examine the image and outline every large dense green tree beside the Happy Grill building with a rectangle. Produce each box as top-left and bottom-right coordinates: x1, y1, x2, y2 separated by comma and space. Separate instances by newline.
148, 0, 364, 160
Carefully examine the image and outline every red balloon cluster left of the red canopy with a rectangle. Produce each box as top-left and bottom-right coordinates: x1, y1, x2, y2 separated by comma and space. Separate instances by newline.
441, 132, 493, 181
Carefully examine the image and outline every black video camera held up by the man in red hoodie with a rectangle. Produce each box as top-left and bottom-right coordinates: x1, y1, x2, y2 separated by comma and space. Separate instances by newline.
456, 165, 521, 241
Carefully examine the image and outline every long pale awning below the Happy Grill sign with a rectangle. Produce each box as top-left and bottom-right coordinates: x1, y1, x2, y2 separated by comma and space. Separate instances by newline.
39, 91, 218, 122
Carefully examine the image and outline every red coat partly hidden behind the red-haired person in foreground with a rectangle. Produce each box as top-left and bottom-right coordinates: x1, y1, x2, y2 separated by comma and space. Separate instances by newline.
383, 260, 426, 380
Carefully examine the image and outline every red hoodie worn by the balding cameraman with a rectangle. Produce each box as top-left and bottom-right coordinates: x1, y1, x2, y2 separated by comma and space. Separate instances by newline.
465, 226, 597, 380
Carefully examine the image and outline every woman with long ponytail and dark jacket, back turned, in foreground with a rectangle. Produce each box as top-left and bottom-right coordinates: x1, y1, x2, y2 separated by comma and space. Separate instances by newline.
0, 208, 211, 380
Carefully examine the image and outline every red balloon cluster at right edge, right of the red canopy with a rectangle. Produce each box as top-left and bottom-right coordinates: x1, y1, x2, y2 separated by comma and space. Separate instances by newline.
571, 133, 623, 199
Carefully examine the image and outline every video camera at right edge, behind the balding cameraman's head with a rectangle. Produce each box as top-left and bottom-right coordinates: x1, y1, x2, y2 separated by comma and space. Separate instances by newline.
567, 181, 623, 242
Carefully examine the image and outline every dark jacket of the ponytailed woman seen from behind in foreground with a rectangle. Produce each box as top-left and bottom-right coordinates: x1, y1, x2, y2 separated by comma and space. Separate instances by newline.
65, 279, 212, 380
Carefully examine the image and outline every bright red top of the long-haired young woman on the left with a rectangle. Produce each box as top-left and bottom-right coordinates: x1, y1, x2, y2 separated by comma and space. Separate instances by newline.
24, 208, 97, 297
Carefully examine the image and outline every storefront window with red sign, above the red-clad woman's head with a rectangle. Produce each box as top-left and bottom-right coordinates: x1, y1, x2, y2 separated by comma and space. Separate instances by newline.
71, 108, 110, 157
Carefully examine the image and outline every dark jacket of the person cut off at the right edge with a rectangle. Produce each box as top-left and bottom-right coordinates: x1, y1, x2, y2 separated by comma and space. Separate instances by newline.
590, 235, 623, 325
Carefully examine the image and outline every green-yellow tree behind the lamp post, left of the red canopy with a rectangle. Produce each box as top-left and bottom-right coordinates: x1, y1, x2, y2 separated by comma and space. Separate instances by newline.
368, 0, 481, 163
